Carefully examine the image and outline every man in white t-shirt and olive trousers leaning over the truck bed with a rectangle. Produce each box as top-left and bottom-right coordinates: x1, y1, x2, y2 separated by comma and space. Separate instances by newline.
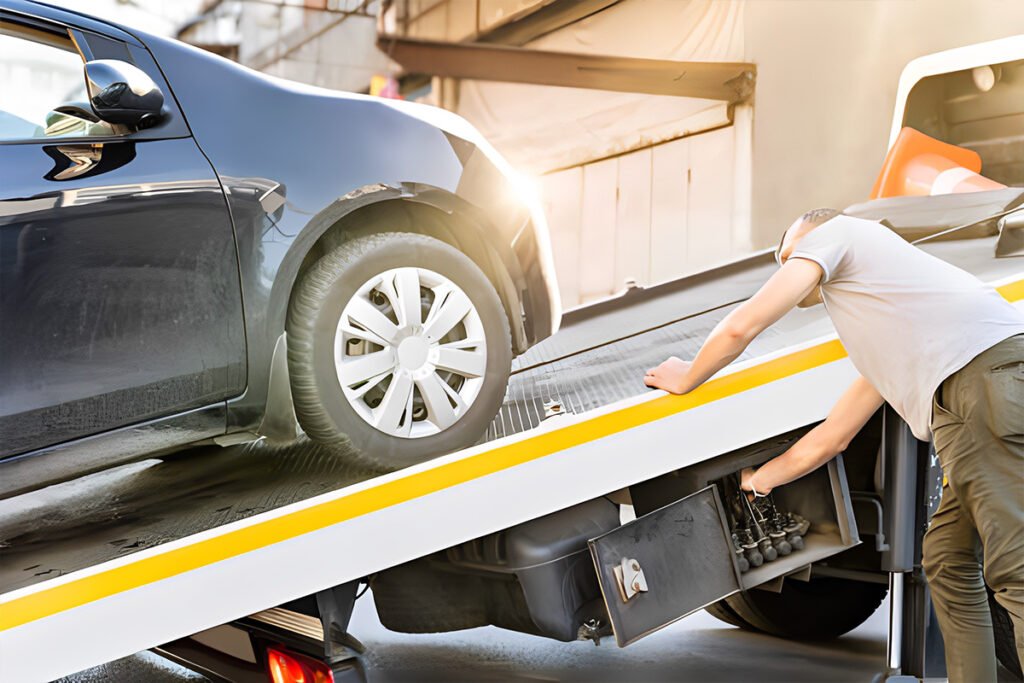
644, 209, 1024, 683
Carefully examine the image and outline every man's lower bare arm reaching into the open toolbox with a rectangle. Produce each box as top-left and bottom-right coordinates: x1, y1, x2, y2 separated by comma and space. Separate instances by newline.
741, 377, 884, 494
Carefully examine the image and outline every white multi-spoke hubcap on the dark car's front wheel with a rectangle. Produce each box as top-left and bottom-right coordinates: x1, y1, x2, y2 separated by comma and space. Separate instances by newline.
335, 267, 487, 438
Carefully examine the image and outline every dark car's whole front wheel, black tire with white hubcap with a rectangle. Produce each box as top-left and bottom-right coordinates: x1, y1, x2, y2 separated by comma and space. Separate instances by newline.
288, 232, 512, 469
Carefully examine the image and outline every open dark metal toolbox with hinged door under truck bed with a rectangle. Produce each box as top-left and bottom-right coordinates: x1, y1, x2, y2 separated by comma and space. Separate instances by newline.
590, 456, 860, 646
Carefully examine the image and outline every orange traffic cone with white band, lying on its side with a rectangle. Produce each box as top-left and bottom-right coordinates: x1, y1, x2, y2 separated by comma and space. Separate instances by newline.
871, 128, 1006, 200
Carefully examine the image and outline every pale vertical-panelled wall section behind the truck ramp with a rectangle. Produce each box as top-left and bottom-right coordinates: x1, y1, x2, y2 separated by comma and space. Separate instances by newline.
541, 121, 750, 307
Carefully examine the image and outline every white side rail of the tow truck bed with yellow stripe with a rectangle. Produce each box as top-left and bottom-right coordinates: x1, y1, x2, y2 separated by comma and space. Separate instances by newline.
0, 242, 1024, 680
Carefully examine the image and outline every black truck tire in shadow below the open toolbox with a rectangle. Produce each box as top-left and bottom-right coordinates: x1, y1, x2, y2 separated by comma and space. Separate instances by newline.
725, 577, 889, 640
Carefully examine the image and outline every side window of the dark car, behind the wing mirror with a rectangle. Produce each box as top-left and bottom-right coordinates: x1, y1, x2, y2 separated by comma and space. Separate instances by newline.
0, 22, 119, 142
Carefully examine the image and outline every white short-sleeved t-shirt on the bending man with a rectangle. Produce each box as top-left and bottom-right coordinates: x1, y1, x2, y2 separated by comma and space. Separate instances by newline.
790, 216, 1024, 441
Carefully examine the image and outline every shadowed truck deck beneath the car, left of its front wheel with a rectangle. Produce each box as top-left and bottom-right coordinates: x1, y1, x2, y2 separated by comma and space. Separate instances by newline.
0, 439, 383, 594
